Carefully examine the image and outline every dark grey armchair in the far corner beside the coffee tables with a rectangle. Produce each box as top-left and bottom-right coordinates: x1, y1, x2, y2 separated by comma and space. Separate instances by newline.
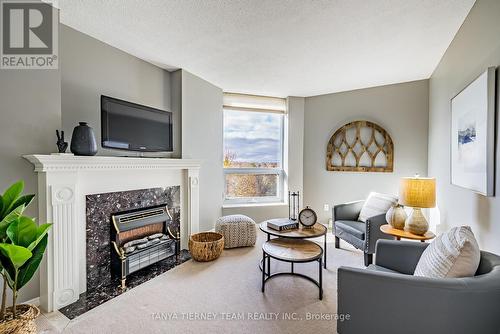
332, 201, 394, 266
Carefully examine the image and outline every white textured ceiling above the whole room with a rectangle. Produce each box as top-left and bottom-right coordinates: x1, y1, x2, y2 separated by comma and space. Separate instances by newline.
58, 0, 474, 96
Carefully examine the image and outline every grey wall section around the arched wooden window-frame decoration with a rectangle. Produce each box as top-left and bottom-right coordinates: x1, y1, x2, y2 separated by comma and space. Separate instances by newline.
304, 80, 428, 222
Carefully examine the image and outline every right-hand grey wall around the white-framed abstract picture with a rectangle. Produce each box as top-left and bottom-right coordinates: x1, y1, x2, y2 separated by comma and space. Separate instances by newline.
429, 0, 500, 253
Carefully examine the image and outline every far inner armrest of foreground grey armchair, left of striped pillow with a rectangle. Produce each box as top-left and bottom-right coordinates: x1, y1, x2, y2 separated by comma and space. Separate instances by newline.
375, 240, 429, 275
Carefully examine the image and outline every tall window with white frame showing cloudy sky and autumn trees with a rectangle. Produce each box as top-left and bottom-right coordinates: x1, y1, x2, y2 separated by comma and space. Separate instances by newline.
224, 93, 286, 204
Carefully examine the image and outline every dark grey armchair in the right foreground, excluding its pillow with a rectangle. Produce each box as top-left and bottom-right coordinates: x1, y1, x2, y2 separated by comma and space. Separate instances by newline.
337, 240, 500, 334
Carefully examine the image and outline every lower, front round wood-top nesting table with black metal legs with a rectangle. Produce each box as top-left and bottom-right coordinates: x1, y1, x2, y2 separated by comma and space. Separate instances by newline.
262, 238, 323, 300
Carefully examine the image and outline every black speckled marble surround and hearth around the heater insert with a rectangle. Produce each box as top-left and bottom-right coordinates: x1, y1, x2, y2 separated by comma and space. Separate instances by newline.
59, 186, 190, 319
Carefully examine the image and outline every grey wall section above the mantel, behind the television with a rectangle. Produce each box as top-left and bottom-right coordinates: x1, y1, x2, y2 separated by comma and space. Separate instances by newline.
59, 24, 181, 157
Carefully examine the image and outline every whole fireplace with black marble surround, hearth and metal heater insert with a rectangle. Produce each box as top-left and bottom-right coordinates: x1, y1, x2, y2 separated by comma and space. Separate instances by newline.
59, 186, 190, 319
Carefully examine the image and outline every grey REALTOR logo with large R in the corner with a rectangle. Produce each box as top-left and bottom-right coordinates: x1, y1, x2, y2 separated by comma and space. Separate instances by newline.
0, 0, 59, 69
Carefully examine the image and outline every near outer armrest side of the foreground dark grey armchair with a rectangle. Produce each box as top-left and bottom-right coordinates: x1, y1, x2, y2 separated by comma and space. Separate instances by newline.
337, 267, 499, 334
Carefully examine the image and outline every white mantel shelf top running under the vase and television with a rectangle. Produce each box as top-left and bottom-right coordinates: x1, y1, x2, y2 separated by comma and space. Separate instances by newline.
23, 154, 201, 172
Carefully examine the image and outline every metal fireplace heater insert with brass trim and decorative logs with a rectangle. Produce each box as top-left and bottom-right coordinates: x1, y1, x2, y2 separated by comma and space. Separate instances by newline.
111, 206, 180, 289
